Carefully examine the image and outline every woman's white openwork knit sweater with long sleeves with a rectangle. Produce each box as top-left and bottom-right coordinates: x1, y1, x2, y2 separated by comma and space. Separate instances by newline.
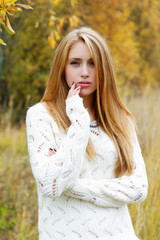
26, 95, 148, 240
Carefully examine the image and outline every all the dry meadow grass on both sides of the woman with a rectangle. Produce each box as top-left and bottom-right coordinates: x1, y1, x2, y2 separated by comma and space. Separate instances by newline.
0, 91, 160, 240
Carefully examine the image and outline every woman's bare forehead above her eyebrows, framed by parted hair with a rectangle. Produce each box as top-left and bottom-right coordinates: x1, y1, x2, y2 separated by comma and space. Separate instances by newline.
68, 41, 92, 59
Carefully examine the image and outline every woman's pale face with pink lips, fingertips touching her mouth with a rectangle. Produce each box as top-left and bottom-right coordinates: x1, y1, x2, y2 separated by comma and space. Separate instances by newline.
65, 41, 97, 97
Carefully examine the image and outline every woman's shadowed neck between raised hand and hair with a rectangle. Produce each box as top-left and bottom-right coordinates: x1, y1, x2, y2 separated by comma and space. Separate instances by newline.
83, 96, 96, 122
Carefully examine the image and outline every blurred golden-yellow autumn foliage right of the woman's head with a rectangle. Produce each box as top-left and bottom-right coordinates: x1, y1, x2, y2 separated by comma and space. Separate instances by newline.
80, 0, 160, 95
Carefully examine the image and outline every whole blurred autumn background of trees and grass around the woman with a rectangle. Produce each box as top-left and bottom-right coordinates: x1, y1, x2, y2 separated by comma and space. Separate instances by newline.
0, 0, 160, 240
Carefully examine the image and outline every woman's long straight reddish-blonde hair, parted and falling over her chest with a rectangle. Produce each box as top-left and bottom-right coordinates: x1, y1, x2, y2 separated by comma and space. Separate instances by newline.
41, 27, 133, 176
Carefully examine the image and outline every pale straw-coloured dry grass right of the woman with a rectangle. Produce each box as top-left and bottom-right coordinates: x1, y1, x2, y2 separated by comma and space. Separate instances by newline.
129, 91, 160, 240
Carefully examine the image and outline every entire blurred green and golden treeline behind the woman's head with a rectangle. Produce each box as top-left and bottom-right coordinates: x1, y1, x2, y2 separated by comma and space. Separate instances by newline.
0, 0, 160, 123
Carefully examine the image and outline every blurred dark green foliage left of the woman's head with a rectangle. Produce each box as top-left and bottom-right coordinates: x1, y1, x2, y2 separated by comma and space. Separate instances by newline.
0, 0, 82, 120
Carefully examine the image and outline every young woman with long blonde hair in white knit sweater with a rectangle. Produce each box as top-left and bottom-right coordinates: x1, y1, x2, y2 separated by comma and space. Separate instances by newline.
26, 27, 148, 240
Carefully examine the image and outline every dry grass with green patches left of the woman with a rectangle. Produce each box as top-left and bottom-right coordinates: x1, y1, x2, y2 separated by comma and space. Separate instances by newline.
0, 126, 38, 240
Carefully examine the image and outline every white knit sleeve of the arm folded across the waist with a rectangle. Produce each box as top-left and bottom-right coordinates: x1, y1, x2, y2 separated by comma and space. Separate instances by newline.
66, 124, 148, 207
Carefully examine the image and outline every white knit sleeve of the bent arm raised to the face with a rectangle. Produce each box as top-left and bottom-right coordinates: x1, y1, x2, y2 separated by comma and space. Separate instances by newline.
26, 96, 90, 198
